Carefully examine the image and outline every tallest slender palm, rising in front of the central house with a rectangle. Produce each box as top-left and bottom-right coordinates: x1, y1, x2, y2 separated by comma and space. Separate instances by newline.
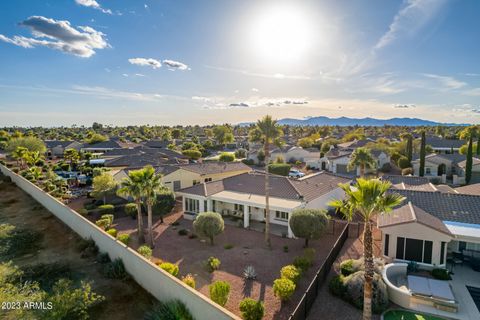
249, 115, 283, 248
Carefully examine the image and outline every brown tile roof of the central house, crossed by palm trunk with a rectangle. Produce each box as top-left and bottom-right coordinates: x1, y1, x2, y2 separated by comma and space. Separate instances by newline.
180, 172, 350, 201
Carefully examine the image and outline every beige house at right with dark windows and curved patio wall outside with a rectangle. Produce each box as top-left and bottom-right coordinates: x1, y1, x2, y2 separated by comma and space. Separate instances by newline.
378, 189, 480, 268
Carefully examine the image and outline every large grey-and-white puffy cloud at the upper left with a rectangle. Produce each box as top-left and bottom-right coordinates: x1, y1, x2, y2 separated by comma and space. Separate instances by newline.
0, 16, 109, 58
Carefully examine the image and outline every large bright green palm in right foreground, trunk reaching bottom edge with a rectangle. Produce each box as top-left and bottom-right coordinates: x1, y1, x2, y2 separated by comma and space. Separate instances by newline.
329, 178, 405, 320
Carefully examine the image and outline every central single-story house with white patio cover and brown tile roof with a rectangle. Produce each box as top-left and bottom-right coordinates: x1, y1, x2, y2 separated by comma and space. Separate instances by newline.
178, 171, 350, 237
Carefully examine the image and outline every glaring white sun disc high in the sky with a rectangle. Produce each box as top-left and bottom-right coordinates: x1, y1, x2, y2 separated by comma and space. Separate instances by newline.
251, 6, 313, 63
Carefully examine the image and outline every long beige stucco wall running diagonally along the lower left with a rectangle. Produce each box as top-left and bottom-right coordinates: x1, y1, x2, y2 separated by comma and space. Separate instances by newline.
0, 165, 240, 320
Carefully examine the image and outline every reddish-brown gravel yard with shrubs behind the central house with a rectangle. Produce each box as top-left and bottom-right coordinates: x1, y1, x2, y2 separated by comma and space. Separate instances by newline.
113, 211, 344, 319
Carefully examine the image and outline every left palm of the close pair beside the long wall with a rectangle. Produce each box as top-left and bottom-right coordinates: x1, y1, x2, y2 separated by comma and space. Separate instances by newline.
117, 169, 145, 243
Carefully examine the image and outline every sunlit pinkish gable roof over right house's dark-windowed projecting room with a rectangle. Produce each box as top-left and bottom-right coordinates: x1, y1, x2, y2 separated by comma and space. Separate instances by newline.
378, 202, 452, 235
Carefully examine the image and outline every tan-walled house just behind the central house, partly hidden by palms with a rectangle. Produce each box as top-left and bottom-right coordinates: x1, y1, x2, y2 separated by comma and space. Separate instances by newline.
113, 161, 252, 191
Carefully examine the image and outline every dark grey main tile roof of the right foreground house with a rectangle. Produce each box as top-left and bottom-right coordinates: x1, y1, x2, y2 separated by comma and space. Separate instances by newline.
394, 190, 480, 224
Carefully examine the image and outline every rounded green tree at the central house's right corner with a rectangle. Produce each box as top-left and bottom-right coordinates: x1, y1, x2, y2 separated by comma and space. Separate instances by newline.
288, 209, 329, 247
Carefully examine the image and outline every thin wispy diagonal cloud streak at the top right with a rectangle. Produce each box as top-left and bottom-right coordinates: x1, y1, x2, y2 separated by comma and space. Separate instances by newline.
374, 0, 447, 49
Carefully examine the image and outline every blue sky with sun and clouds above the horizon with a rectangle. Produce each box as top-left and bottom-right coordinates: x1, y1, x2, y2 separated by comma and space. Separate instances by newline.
0, 0, 480, 126
